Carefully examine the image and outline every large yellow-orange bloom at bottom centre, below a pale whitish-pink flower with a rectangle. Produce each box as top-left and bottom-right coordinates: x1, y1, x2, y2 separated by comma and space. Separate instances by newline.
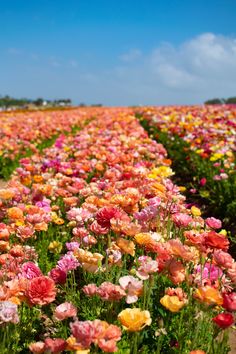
118, 308, 152, 332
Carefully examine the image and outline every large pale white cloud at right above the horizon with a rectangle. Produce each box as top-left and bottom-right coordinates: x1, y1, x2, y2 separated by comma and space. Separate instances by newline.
110, 33, 236, 104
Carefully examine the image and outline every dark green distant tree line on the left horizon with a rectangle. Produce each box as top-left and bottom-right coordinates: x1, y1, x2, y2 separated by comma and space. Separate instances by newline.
0, 95, 71, 108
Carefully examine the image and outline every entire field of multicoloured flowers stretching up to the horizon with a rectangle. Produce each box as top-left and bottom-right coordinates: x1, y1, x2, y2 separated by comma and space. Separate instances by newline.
0, 107, 236, 354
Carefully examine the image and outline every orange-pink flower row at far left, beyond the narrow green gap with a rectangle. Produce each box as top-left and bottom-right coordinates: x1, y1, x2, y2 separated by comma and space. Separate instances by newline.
0, 108, 96, 160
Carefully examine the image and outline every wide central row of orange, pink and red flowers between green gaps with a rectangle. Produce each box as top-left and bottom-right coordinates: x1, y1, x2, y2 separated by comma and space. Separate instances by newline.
0, 109, 236, 354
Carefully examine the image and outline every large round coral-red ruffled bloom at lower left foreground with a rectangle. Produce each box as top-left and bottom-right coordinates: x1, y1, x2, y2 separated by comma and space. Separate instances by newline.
26, 276, 56, 305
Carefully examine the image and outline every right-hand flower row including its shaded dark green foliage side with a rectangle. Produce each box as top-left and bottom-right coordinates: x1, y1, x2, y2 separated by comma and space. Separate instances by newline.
138, 106, 236, 231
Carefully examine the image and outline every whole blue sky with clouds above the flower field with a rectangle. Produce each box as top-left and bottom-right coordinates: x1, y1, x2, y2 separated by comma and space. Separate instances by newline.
0, 0, 236, 105
